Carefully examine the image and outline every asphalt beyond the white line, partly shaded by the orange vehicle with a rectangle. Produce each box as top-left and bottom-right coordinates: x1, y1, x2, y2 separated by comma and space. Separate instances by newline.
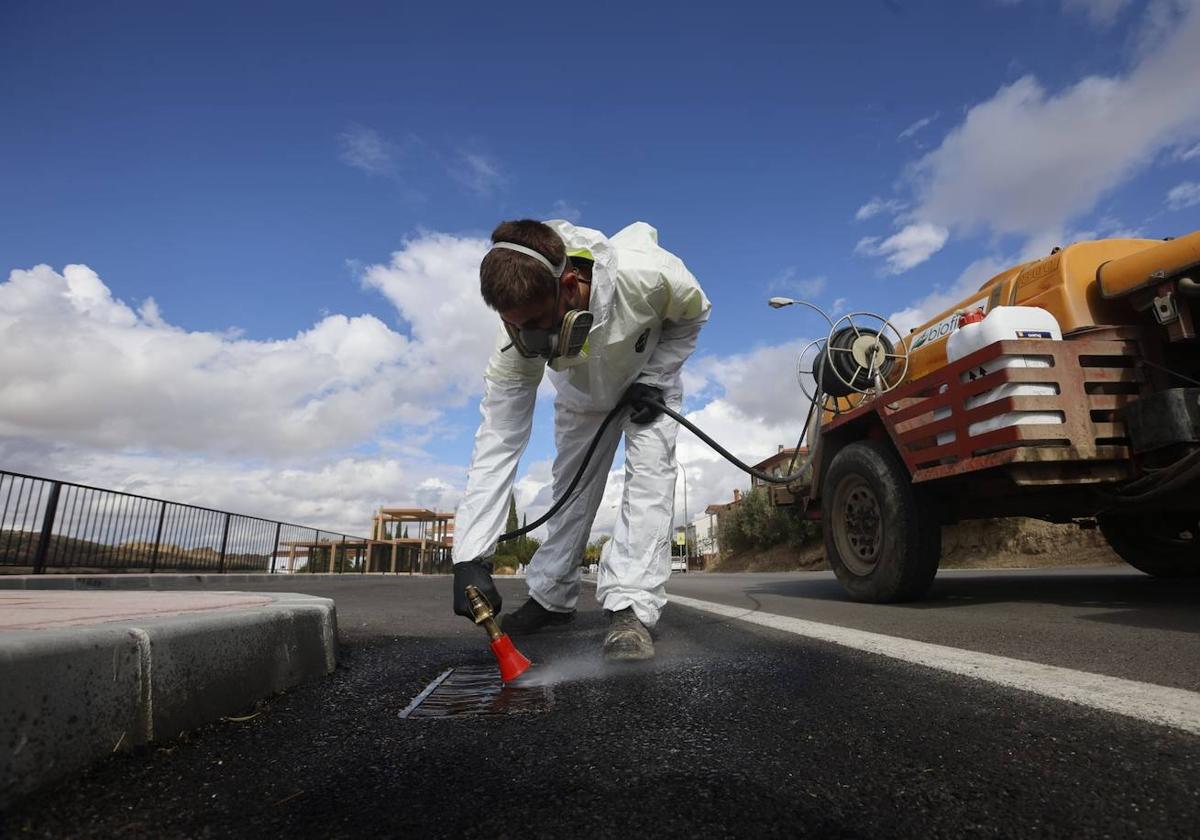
671, 566, 1200, 691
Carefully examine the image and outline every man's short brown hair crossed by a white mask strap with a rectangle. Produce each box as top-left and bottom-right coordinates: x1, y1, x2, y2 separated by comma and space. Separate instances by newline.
479, 218, 566, 312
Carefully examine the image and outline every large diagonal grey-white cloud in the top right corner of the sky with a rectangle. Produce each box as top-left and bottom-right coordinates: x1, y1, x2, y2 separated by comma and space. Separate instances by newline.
912, 2, 1200, 235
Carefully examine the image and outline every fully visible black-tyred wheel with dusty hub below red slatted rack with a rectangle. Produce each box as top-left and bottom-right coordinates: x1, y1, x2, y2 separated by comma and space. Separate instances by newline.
821, 440, 942, 604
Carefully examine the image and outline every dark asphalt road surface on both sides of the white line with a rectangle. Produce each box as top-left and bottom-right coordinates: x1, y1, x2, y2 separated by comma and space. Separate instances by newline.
0, 570, 1200, 838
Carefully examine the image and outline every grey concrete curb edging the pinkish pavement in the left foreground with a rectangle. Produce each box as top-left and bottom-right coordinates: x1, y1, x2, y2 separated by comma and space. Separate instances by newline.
0, 588, 337, 808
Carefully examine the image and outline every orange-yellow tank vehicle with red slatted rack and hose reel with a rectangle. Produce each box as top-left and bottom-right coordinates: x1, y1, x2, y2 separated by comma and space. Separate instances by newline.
773, 232, 1200, 601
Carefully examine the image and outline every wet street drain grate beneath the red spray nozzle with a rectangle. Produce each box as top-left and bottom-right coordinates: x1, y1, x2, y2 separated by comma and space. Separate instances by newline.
400, 665, 554, 718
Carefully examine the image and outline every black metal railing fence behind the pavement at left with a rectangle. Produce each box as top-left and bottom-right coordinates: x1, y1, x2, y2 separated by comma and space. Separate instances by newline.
0, 470, 370, 575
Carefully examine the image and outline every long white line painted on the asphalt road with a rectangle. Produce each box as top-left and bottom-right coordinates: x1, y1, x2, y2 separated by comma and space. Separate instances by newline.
667, 595, 1200, 734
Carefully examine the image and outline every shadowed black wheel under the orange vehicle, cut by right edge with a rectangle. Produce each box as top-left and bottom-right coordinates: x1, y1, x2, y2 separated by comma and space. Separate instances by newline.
1099, 510, 1200, 577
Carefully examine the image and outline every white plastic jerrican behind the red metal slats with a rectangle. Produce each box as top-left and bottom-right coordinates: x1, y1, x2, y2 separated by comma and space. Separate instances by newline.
934, 306, 1066, 445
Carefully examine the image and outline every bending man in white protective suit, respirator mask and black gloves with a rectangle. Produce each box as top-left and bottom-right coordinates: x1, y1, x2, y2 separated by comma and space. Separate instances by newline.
454, 220, 712, 660
